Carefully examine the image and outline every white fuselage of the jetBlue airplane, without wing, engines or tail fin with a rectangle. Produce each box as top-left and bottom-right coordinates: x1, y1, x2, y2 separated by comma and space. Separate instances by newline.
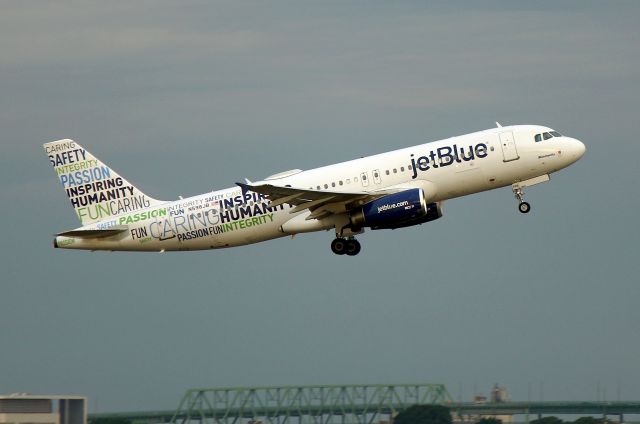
56, 125, 584, 251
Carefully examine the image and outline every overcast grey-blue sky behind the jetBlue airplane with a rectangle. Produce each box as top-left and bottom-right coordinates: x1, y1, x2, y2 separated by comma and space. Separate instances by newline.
0, 1, 640, 412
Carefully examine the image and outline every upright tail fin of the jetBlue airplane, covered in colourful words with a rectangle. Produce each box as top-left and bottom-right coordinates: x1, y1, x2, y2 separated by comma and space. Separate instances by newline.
43, 139, 164, 225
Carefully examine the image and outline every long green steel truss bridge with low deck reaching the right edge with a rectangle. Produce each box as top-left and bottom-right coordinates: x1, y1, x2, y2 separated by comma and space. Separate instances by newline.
89, 384, 640, 424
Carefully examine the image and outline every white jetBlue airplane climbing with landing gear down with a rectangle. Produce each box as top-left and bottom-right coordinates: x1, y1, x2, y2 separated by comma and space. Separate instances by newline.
44, 122, 585, 256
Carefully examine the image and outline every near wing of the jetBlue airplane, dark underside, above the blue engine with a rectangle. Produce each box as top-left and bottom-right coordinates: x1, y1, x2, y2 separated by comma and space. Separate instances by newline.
236, 182, 398, 219
